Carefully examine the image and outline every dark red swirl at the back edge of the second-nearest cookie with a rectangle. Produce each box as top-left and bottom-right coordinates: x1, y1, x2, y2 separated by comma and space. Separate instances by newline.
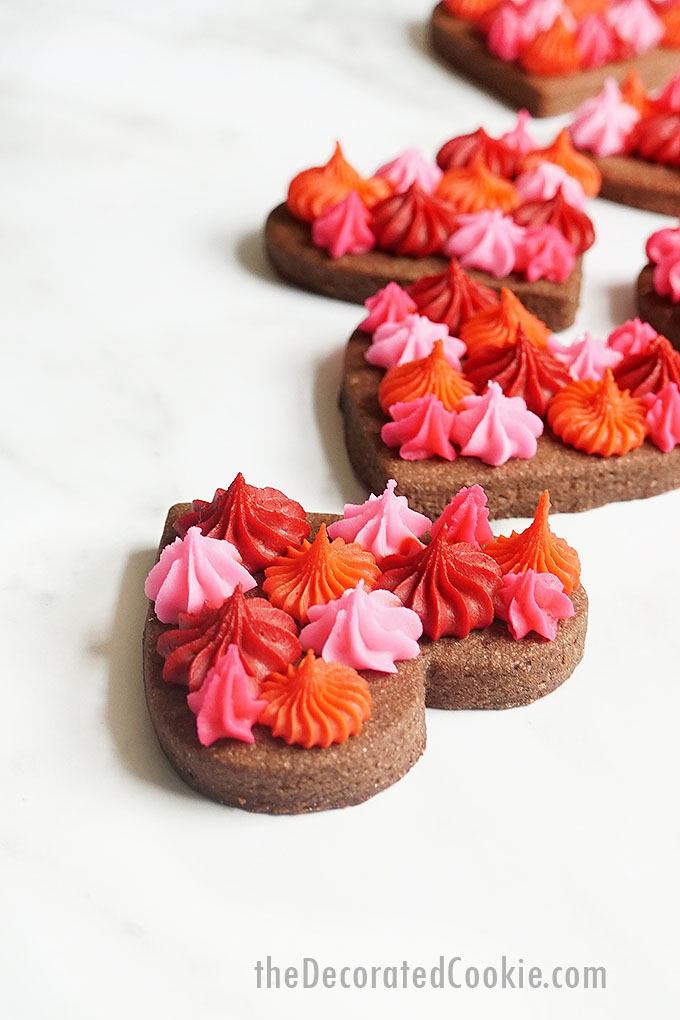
408, 258, 499, 337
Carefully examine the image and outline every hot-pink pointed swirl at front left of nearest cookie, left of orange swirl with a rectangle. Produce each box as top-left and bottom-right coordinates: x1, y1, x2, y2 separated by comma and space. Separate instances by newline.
187, 645, 267, 747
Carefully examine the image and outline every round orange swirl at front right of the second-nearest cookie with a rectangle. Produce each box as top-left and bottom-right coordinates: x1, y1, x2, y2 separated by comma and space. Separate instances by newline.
547, 368, 647, 457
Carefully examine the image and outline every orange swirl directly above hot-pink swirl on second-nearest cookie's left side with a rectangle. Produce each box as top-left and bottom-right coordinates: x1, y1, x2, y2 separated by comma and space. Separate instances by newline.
378, 340, 474, 414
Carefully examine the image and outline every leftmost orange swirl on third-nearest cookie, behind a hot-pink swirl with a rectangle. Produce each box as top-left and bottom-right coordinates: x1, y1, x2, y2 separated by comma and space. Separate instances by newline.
286, 142, 391, 223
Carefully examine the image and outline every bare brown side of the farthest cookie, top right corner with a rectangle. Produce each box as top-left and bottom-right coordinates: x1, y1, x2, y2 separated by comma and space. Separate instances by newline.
430, 3, 678, 117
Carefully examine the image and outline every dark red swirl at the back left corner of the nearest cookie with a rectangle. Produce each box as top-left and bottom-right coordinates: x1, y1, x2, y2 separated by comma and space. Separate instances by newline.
174, 471, 309, 570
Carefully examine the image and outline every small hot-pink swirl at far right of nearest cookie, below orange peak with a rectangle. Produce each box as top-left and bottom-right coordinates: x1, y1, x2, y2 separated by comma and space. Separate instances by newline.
493, 567, 574, 641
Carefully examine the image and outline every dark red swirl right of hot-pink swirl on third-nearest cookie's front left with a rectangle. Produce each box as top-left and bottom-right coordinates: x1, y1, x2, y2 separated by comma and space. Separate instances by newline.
370, 184, 458, 258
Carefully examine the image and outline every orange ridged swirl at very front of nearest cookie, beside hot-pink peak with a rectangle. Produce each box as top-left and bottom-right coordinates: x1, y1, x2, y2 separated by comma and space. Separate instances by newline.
259, 652, 372, 748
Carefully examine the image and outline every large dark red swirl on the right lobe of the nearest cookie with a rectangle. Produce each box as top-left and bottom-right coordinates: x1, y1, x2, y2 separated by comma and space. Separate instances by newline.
378, 528, 503, 641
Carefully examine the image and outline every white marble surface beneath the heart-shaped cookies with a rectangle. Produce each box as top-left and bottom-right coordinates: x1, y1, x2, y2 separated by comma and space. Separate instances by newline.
0, 0, 680, 1020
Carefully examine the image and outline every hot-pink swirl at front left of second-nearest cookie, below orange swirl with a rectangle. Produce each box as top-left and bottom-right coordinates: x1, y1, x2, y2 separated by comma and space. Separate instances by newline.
380, 394, 456, 460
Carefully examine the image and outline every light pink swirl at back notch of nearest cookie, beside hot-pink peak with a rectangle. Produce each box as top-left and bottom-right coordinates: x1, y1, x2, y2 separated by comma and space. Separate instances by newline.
328, 478, 432, 561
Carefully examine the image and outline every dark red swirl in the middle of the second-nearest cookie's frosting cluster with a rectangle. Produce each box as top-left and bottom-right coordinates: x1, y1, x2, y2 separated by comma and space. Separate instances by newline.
465, 326, 571, 418
